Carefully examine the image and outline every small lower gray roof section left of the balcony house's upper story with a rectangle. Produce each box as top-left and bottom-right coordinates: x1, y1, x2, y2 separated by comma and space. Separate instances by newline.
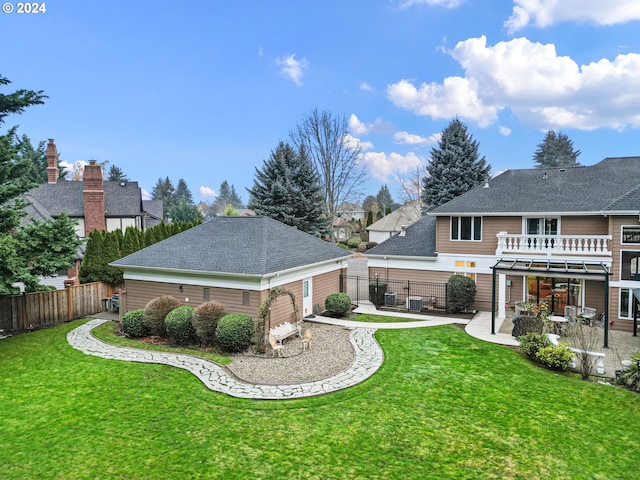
367, 216, 437, 257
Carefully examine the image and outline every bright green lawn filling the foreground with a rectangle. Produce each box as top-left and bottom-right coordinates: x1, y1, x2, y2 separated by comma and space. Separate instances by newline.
0, 316, 640, 480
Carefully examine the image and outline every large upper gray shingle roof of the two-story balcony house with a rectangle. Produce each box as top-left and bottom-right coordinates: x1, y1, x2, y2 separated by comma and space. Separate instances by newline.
429, 157, 640, 215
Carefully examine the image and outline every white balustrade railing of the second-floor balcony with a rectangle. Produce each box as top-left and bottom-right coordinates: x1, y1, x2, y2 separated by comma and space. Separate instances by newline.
496, 232, 612, 256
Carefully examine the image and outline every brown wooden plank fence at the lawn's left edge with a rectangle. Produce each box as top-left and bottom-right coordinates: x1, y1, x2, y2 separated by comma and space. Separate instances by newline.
0, 282, 117, 333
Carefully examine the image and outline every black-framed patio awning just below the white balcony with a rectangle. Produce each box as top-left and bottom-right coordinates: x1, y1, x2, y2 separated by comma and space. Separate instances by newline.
491, 258, 610, 280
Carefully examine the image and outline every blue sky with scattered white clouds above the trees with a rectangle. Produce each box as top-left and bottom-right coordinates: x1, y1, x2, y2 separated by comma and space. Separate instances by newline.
0, 0, 640, 202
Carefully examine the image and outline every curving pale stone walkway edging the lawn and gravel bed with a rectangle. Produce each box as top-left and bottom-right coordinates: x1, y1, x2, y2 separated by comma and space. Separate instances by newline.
67, 319, 384, 400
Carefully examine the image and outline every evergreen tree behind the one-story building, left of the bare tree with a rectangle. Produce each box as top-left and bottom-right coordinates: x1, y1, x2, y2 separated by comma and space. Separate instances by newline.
248, 142, 328, 236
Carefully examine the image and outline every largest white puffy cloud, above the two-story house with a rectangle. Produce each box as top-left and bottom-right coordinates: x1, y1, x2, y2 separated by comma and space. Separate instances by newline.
387, 36, 640, 130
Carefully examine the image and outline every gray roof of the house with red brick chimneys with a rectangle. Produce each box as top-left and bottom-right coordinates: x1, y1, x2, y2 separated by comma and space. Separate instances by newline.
25, 180, 142, 217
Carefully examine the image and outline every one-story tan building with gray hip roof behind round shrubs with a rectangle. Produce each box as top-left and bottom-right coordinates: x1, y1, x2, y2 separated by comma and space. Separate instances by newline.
111, 216, 351, 336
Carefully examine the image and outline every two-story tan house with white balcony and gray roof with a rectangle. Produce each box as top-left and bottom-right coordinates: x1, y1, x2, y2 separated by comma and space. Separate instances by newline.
367, 157, 640, 330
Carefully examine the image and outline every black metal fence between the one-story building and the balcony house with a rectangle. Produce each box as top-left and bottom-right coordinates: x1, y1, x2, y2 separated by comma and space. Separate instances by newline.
340, 275, 448, 313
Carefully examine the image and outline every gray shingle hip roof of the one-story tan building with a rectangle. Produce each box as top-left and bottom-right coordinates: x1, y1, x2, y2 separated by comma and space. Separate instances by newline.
113, 217, 351, 275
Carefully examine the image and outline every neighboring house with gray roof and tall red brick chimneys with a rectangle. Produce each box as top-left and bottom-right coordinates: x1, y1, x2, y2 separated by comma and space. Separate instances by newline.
24, 139, 162, 238
